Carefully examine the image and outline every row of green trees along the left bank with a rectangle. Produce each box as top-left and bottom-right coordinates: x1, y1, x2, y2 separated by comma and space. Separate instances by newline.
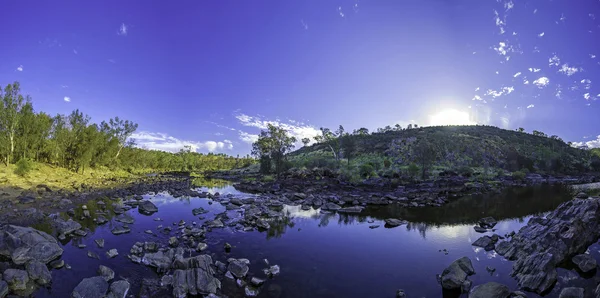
0, 82, 254, 172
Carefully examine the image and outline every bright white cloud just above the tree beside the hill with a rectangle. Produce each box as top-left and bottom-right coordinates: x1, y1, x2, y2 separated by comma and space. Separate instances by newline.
235, 114, 321, 146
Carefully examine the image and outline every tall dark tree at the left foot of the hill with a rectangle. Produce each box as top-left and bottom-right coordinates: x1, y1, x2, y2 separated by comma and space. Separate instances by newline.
252, 124, 296, 176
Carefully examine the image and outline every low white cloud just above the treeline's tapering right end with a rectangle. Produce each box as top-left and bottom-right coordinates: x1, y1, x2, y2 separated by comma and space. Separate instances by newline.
130, 131, 233, 152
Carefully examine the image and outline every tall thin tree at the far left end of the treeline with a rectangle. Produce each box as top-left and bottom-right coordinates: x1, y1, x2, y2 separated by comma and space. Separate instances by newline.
0, 82, 29, 165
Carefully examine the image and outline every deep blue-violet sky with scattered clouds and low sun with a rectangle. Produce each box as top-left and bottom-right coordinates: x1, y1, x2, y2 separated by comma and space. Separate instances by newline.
0, 0, 600, 155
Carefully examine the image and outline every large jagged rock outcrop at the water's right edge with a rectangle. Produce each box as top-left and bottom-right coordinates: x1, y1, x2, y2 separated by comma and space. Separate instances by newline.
496, 198, 600, 293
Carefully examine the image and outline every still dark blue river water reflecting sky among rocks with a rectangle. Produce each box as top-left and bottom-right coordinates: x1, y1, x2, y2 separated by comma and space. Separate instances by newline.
35, 185, 600, 297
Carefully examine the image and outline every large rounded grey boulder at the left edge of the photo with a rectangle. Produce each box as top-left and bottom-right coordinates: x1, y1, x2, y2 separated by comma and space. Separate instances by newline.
0, 225, 63, 265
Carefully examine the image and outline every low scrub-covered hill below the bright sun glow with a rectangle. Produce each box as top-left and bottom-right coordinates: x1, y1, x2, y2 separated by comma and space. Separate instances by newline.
288, 125, 600, 178
